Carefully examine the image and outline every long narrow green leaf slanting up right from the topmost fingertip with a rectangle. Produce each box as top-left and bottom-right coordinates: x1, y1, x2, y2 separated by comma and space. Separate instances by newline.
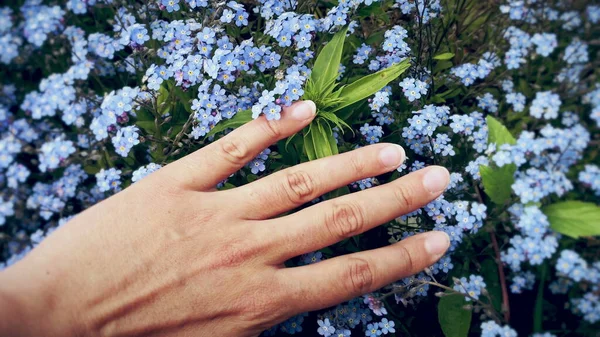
331, 59, 410, 112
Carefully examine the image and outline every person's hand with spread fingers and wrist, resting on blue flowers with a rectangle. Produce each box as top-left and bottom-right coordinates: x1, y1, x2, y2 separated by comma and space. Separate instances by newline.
0, 101, 449, 337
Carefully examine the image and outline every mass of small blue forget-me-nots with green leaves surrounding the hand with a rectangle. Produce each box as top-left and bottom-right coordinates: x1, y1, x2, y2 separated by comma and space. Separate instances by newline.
0, 0, 600, 337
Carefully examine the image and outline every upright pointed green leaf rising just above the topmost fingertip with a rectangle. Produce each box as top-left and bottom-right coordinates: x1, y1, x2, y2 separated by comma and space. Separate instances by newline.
310, 27, 348, 92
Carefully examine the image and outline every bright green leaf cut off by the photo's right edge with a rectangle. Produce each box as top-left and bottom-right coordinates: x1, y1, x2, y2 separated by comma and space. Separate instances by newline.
542, 201, 600, 238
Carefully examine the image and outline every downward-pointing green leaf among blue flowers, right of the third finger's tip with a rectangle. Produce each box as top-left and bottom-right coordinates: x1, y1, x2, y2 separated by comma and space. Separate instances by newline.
479, 164, 517, 205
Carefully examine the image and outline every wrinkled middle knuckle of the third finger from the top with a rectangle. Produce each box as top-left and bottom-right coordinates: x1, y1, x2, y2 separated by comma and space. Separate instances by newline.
325, 203, 365, 240
